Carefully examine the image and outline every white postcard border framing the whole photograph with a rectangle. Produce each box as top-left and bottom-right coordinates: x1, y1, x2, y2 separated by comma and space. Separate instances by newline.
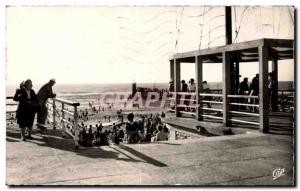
0, 0, 300, 190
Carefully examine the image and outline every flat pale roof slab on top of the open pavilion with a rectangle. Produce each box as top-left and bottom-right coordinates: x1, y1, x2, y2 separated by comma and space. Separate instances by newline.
169, 38, 294, 63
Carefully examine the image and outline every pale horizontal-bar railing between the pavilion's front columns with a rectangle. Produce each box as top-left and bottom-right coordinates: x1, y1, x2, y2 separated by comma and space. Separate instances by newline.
171, 92, 259, 125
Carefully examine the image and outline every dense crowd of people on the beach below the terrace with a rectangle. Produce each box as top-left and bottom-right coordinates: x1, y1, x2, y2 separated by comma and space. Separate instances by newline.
74, 112, 170, 147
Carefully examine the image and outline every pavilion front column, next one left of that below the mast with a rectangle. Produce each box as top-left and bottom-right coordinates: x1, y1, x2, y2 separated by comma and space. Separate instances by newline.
195, 56, 203, 121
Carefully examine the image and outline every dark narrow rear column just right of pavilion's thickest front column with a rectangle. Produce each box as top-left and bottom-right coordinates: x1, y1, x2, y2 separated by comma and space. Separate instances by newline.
271, 58, 278, 111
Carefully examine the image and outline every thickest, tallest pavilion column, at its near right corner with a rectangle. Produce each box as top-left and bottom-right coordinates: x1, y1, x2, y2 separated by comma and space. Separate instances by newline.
258, 46, 269, 133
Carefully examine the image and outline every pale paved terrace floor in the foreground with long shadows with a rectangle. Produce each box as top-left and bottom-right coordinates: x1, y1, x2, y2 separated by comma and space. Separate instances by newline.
6, 112, 294, 185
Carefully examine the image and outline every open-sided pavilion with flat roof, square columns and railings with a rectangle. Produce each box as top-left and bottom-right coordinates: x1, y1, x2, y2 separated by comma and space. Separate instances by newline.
169, 38, 295, 133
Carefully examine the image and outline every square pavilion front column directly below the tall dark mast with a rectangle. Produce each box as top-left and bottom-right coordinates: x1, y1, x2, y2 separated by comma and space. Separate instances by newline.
222, 52, 232, 127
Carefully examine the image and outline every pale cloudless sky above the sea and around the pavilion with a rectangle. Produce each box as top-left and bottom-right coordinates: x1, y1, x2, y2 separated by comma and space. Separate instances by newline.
6, 6, 294, 85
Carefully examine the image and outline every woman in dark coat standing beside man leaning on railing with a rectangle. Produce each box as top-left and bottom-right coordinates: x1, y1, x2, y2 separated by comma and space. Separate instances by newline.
17, 79, 39, 141
